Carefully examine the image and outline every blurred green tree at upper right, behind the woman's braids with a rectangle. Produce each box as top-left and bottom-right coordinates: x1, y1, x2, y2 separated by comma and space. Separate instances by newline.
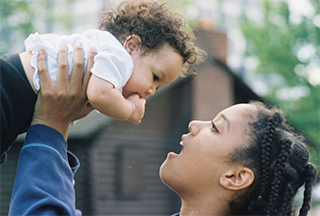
240, 0, 320, 165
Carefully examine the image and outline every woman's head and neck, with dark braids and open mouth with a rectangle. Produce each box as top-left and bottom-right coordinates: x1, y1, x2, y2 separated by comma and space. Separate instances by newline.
160, 102, 316, 215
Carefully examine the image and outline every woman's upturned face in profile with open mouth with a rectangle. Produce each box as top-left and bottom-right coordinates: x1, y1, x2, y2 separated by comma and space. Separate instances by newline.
160, 104, 255, 195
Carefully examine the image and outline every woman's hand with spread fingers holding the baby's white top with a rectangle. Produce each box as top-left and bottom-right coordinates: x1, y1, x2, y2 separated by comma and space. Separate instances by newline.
31, 43, 96, 139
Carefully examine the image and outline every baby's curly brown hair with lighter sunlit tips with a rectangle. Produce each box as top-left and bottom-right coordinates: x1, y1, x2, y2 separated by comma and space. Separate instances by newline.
98, 0, 204, 75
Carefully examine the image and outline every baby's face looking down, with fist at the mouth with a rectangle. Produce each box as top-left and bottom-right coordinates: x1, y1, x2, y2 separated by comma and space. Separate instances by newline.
123, 44, 183, 99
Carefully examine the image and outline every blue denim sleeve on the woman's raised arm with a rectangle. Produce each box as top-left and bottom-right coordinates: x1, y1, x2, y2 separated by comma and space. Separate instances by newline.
9, 125, 81, 215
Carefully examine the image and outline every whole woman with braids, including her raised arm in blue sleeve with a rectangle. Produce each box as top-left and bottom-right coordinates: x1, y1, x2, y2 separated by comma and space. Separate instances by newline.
10, 48, 316, 216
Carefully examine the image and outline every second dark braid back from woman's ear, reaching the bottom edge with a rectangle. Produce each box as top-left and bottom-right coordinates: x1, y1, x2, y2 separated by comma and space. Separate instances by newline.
266, 140, 292, 216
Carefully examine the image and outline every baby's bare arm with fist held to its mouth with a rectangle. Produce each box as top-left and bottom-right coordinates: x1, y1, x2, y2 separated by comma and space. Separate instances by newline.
87, 74, 145, 124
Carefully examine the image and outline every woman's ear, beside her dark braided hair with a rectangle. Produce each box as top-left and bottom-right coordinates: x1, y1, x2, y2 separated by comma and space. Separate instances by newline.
220, 167, 254, 190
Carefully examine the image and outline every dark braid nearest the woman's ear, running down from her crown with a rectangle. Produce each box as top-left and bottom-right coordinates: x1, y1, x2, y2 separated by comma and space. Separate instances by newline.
260, 113, 283, 196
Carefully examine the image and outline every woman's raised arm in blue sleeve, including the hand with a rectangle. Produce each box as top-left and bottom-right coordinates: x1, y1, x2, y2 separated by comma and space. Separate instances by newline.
10, 46, 95, 215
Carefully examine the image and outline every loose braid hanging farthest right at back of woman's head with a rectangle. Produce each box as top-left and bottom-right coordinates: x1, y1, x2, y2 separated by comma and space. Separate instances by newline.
299, 163, 316, 216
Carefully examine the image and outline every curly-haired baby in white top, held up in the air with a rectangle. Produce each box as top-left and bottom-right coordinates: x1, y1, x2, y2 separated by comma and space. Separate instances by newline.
1, 1, 201, 162
